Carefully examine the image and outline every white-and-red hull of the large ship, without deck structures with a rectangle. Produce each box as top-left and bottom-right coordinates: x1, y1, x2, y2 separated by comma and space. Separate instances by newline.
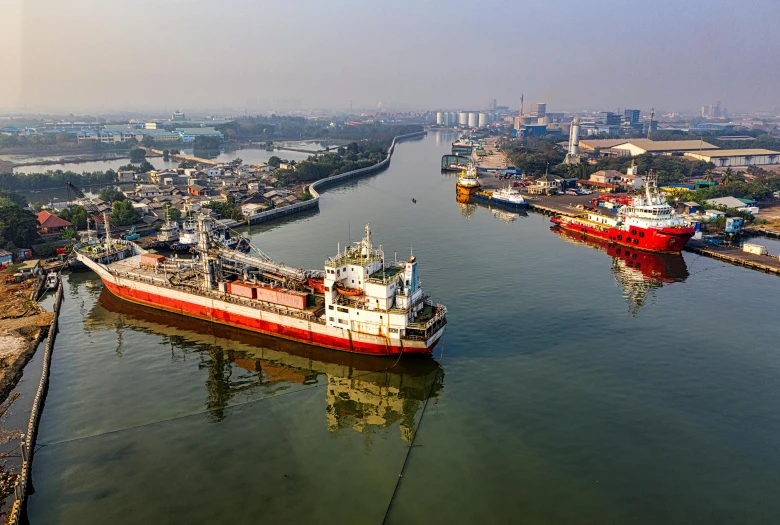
81, 257, 445, 356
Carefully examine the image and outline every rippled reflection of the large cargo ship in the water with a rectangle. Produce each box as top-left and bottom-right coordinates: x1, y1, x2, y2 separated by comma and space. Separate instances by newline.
86, 290, 444, 441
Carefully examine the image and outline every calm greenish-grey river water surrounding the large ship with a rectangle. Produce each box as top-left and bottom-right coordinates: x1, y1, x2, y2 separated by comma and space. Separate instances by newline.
29, 134, 780, 525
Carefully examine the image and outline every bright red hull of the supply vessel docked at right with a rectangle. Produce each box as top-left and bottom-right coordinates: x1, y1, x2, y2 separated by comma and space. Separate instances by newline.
550, 217, 693, 253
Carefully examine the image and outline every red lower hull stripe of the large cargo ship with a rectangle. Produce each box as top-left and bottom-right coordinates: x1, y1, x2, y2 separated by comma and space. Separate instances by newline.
103, 280, 435, 355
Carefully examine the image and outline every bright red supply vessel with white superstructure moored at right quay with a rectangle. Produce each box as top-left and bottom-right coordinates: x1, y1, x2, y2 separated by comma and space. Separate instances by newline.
551, 174, 694, 253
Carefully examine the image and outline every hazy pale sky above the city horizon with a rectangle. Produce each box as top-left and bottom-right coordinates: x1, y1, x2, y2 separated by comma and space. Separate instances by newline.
0, 0, 780, 112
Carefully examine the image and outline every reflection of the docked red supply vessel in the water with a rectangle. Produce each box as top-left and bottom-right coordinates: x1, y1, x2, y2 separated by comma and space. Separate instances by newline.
550, 227, 689, 317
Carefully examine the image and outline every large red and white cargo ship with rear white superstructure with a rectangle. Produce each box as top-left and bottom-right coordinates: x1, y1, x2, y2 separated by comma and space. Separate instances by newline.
74, 217, 447, 355
